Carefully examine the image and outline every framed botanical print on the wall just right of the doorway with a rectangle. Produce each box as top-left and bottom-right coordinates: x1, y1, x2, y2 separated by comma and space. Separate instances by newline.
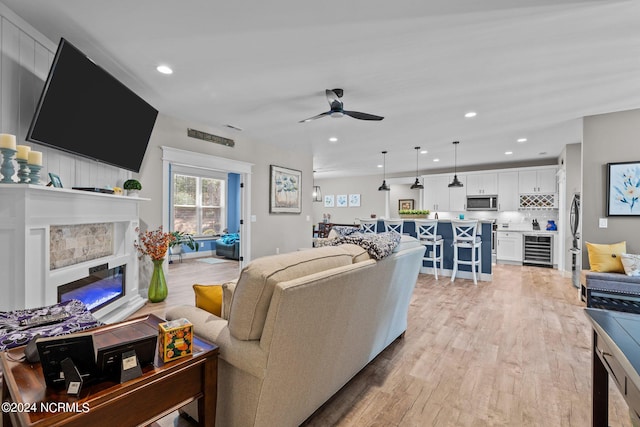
269, 165, 302, 214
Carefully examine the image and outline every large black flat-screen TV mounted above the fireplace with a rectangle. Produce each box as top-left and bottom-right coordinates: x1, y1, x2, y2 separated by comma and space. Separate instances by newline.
27, 38, 158, 172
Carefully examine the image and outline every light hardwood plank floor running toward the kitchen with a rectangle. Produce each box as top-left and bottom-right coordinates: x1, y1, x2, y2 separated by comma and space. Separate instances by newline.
146, 261, 631, 427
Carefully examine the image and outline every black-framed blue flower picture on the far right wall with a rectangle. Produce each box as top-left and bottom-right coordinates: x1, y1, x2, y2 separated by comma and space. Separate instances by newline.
607, 161, 640, 216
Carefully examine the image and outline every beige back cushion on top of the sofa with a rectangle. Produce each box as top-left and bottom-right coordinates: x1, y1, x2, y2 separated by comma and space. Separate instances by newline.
229, 247, 353, 341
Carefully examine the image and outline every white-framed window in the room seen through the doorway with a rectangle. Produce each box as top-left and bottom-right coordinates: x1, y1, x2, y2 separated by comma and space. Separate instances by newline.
171, 170, 227, 236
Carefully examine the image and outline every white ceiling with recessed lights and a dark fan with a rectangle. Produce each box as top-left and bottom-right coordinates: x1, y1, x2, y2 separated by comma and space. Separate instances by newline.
2, 0, 640, 178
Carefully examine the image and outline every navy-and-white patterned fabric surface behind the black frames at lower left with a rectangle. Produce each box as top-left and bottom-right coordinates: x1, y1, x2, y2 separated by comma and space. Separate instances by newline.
0, 300, 102, 351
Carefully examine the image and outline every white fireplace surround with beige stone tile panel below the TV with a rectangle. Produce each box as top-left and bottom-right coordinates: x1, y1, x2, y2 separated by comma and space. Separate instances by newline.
0, 184, 147, 323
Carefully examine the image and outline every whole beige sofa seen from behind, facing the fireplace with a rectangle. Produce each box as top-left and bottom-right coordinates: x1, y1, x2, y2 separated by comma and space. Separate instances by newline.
167, 236, 424, 427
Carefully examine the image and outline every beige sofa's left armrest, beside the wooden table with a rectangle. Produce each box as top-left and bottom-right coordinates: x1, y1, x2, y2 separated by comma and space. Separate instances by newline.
166, 305, 268, 378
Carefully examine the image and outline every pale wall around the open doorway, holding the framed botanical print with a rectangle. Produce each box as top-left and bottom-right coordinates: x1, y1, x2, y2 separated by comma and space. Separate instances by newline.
139, 114, 313, 259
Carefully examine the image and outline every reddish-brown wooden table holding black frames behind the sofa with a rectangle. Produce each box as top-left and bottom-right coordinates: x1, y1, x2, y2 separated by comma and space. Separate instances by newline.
0, 315, 218, 427
